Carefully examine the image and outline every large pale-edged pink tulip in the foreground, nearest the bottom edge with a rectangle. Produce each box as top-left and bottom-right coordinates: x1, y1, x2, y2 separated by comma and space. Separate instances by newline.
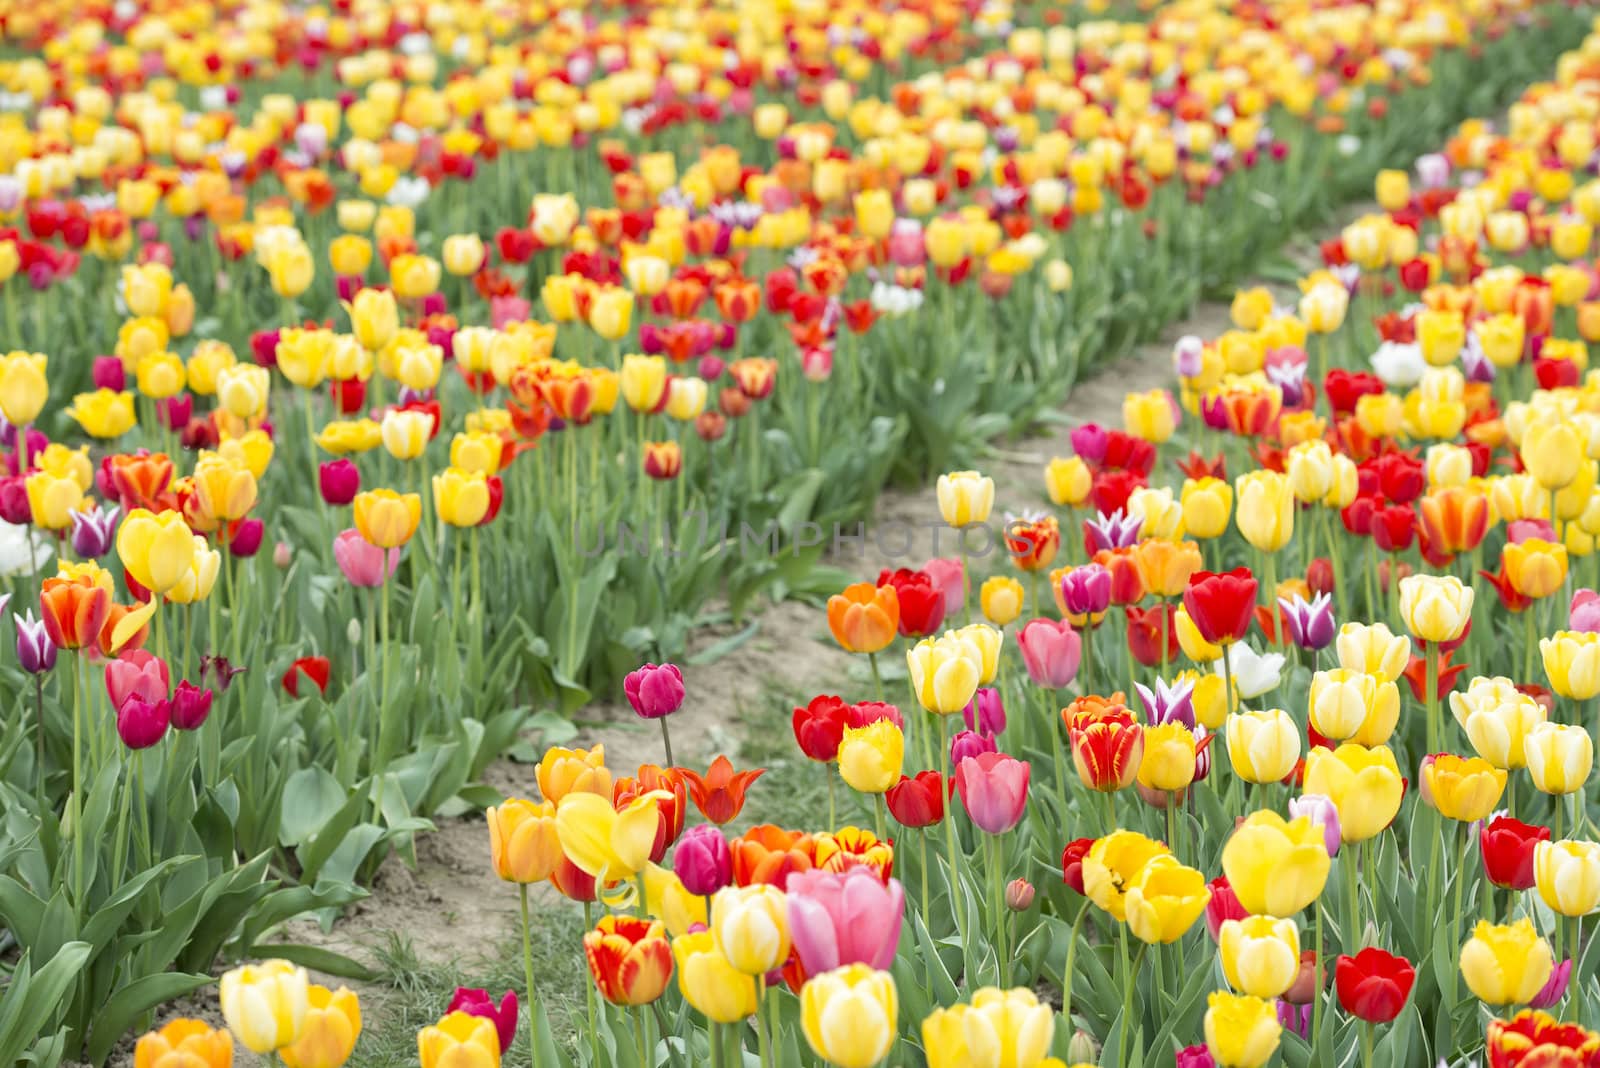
787, 867, 906, 975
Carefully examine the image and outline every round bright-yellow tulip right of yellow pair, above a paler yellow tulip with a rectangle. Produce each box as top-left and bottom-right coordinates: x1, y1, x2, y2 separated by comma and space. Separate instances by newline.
1222, 809, 1331, 916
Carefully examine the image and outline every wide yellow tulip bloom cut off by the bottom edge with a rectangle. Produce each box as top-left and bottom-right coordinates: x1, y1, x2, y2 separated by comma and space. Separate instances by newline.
922, 986, 1059, 1068
